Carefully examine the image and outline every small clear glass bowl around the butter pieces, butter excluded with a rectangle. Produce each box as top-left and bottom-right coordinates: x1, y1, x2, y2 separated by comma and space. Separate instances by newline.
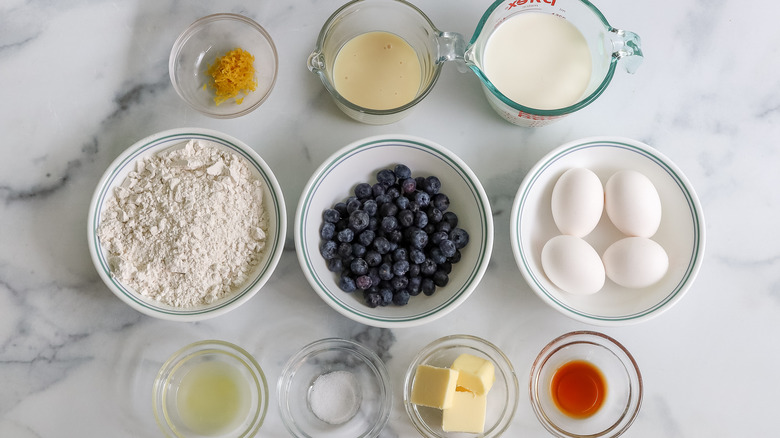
404, 335, 520, 438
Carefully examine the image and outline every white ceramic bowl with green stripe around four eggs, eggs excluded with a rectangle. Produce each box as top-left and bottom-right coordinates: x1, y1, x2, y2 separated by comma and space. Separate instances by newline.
510, 137, 705, 326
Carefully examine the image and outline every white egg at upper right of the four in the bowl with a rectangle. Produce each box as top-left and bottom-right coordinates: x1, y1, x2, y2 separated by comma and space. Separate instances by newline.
604, 170, 661, 237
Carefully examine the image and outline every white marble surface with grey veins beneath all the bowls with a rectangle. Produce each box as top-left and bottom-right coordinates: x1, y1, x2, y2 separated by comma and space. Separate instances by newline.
0, 0, 780, 438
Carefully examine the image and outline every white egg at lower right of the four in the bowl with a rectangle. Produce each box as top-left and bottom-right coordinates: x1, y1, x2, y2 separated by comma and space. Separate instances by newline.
602, 237, 669, 289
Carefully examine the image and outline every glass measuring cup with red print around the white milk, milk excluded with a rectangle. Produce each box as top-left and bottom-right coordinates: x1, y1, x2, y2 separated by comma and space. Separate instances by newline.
463, 0, 642, 127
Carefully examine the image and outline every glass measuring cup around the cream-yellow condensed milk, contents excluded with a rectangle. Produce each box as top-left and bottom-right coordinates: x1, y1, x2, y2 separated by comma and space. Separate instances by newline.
307, 0, 450, 125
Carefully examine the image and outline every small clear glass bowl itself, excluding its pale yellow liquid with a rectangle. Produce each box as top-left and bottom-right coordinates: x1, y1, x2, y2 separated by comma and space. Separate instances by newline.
154, 340, 268, 438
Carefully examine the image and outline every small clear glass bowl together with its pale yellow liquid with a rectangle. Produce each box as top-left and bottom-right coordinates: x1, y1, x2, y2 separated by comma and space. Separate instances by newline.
154, 340, 268, 438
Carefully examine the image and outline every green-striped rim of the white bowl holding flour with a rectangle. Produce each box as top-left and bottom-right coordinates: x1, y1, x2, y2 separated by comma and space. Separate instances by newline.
90, 132, 283, 316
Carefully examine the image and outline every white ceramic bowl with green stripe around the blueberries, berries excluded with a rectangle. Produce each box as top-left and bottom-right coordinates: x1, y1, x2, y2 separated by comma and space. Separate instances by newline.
294, 135, 493, 327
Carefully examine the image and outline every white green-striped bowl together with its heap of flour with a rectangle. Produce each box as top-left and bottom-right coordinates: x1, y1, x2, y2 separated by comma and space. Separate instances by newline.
88, 128, 287, 321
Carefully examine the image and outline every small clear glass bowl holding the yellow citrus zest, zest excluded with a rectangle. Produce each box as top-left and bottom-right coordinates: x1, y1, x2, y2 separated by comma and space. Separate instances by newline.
168, 14, 279, 119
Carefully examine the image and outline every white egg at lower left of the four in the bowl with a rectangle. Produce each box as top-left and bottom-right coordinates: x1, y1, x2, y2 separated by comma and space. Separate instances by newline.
542, 234, 605, 295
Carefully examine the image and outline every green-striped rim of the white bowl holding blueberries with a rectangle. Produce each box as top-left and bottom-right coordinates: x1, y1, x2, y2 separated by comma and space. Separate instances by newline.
297, 138, 490, 322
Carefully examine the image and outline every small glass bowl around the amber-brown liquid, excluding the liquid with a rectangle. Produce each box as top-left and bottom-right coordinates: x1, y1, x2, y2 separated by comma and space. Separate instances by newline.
529, 331, 643, 438
